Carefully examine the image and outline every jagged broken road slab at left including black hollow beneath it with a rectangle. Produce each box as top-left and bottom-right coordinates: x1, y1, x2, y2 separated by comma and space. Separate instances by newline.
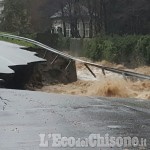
0, 41, 46, 89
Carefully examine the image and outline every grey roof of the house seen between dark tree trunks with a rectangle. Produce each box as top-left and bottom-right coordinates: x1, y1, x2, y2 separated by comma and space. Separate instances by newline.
50, 5, 88, 19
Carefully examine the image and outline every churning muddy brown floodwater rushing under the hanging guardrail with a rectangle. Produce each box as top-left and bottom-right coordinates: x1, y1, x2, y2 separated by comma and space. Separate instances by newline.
41, 61, 150, 99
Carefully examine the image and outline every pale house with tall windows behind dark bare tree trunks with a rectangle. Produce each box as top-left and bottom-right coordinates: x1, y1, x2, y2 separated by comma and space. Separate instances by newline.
50, 6, 89, 38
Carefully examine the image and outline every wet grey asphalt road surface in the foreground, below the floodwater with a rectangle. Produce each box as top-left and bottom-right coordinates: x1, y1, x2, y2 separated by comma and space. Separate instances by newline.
0, 89, 150, 150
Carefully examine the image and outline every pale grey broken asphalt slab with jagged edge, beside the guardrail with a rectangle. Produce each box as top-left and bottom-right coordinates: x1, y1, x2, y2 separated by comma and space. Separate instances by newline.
0, 41, 45, 74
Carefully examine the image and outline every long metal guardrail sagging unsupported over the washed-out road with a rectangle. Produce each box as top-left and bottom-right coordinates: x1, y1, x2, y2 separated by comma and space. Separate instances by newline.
0, 34, 150, 80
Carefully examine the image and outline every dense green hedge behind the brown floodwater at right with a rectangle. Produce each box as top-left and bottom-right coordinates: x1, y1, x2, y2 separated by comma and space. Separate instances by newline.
86, 35, 150, 66
